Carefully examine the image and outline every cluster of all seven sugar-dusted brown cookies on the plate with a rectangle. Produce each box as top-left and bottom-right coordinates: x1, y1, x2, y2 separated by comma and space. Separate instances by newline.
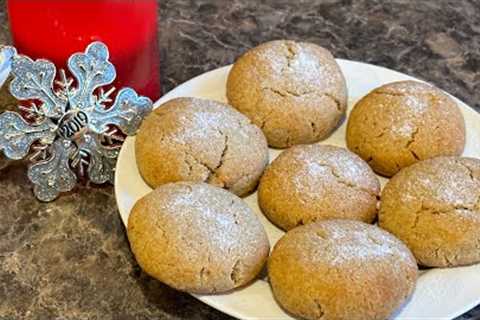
128, 40, 480, 320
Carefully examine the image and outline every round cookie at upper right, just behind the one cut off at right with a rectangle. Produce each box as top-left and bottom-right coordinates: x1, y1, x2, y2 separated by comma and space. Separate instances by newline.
347, 81, 465, 177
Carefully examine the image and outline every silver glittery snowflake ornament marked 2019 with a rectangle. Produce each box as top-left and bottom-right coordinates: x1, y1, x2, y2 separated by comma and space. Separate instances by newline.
0, 42, 152, 201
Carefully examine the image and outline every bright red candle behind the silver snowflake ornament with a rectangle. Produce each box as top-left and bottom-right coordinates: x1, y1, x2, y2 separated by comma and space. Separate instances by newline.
8, 0, 161, 101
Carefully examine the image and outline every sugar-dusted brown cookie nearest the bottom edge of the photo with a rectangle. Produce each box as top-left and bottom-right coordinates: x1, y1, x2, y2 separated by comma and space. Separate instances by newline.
268, 220, 418, 320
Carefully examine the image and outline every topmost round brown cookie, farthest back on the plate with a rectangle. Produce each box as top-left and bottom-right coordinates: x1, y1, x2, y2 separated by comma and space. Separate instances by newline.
227, 40, 347, 148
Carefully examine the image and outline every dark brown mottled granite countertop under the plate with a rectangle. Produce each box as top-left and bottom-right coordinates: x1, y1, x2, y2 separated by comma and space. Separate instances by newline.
0, 0, 480, 320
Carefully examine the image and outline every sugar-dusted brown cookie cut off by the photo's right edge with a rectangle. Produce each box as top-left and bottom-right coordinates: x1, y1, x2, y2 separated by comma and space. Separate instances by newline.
379, 157, 480, 267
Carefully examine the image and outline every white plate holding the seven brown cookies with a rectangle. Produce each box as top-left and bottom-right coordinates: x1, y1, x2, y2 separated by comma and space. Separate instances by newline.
115, 59, 480, 320
